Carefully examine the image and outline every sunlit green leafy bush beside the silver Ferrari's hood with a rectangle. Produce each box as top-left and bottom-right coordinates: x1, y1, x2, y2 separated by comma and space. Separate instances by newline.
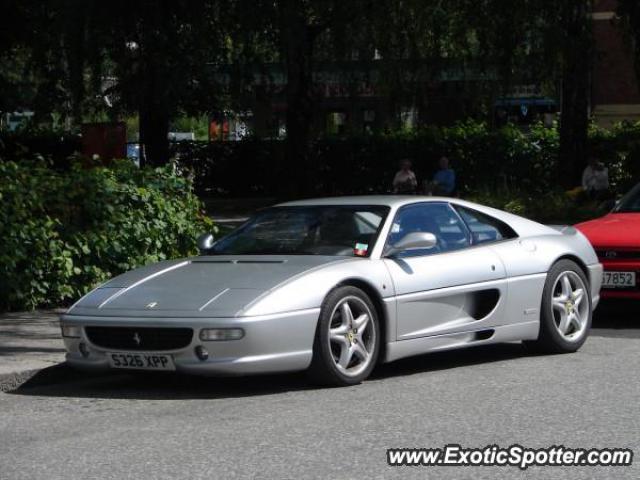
0, 159, 213, 310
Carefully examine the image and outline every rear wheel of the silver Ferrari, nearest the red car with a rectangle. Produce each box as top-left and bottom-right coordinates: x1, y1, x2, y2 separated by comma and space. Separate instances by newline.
527, 260, 593, 353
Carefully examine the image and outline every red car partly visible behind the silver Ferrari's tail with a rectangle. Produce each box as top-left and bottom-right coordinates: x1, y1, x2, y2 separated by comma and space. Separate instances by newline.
576, 184, 640, 299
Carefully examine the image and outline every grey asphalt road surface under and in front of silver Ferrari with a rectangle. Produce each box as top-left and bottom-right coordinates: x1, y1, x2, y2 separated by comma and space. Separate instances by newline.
0, 307, 640, 480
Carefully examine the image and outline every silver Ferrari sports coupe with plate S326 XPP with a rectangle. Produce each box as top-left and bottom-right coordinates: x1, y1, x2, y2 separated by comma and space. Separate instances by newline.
61, 196, 602, 385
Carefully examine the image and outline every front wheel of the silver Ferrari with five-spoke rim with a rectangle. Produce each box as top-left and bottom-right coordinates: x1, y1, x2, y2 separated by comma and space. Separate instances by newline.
309, 286, 380, 386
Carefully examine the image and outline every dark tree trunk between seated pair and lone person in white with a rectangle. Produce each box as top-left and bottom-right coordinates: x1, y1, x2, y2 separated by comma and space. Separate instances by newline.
559, 0, 592, 188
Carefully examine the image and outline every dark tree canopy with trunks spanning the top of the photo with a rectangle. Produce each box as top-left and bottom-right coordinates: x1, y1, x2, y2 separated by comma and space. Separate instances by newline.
0, 0, 640, 182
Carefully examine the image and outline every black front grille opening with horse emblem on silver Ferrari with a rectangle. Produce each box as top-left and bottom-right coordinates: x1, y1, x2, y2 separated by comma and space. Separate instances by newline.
84, 327, 193, 351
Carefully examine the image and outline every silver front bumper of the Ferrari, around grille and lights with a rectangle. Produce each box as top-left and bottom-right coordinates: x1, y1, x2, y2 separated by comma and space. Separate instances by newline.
61, 308, 320, 376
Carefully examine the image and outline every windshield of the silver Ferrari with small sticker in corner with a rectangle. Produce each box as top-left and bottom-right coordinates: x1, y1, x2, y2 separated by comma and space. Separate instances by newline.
207, 205, 389, 257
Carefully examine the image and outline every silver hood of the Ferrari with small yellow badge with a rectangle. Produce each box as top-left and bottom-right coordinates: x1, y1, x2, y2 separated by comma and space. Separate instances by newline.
67, 255, 349, 318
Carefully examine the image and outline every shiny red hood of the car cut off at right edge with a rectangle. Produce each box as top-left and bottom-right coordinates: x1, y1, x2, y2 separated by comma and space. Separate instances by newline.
576, 213, 640, 248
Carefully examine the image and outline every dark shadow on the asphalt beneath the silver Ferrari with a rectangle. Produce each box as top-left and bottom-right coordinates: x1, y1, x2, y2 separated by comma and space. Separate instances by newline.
6, 344, 527, 400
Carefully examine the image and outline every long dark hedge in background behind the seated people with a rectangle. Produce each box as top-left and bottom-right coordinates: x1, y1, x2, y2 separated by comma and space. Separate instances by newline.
173, 121, 640, 196
